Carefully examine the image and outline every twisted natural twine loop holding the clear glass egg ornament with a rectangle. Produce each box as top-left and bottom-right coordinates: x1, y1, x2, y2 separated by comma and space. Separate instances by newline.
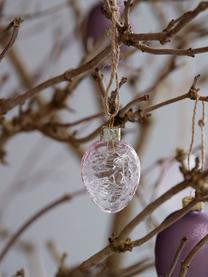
104, 0, 120, 122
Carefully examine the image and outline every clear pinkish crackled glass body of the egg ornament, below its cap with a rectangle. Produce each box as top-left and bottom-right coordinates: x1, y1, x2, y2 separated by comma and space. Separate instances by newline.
81, 141, 140, 213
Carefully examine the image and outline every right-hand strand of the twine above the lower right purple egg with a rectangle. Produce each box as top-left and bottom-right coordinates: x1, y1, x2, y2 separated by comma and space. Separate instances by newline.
198, 101, 206, 170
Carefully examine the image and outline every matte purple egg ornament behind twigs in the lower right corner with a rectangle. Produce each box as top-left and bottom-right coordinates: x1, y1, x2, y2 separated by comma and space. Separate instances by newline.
155, 198, 208, 277
